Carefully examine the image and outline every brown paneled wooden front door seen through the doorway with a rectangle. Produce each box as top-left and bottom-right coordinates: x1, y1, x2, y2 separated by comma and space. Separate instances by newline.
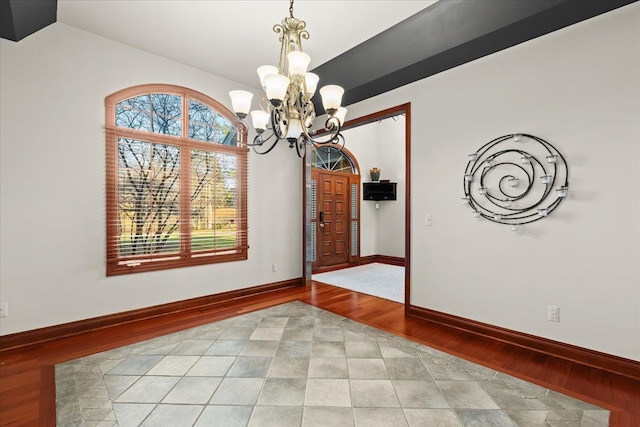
316, 171, 350, 268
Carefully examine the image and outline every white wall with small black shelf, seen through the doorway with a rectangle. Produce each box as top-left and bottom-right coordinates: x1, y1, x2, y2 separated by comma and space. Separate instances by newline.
342, 114, 405, 258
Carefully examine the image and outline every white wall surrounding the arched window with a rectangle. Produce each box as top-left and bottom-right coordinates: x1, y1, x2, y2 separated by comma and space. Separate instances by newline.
0, 23, 302, 334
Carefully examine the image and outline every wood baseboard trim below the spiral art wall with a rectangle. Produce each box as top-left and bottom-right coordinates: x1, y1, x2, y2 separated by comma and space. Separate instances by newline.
408, 305, 640, 381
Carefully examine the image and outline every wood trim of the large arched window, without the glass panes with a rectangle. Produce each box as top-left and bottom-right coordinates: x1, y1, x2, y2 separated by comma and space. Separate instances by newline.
105, 84, 249, 276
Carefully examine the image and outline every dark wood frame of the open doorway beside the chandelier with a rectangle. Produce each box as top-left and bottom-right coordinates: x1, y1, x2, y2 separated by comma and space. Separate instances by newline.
302, 102, 411, 314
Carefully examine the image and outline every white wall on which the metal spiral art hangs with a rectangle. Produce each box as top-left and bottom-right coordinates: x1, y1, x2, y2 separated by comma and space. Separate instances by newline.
342, 3, 640, 360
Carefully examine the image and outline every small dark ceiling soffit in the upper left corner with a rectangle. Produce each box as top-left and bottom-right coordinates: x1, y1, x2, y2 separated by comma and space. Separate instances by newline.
0, 0, 58, 42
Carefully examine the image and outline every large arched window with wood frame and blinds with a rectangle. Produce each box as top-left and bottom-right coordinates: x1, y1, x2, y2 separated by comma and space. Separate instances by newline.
105, 85, 248, 275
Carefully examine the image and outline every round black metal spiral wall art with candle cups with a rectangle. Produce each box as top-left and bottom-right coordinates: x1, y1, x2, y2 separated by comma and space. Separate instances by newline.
462, 133, 569, 231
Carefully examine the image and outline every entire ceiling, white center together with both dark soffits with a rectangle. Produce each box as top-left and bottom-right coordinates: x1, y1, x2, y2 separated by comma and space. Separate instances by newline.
0, 0, 638, 112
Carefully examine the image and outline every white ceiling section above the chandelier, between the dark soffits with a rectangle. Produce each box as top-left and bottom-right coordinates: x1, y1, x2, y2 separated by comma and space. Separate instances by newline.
58, 0, 437, 87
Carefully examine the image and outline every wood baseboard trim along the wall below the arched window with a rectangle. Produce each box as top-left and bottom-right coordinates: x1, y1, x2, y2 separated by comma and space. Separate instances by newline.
0, 277, 303, 354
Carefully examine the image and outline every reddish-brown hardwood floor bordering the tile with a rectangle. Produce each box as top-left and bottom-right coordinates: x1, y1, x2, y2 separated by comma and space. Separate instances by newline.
0, 283, 640, 427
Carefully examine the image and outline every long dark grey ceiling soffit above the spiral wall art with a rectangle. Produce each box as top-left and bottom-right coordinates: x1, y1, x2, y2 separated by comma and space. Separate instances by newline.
313, 0, 638, 114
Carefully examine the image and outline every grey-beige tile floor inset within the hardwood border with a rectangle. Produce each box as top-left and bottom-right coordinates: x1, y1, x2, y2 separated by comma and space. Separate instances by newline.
56, 302, 609, 427
